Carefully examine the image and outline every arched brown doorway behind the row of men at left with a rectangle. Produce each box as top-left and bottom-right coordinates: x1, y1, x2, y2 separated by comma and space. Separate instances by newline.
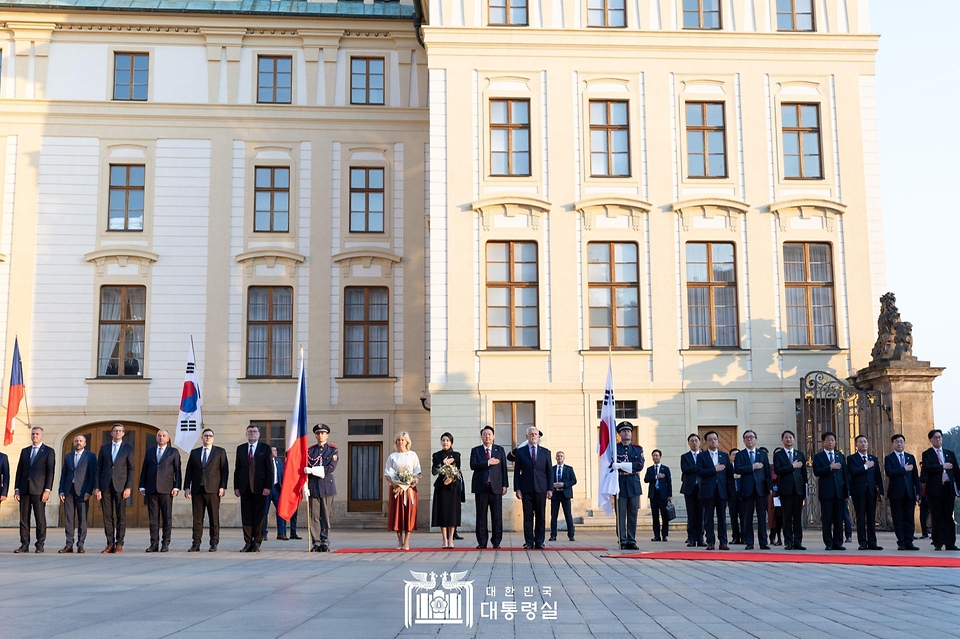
60, 421, 159, 530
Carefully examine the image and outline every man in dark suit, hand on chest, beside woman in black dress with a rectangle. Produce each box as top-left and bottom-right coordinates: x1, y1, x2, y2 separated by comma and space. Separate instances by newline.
470, 426, 510, 548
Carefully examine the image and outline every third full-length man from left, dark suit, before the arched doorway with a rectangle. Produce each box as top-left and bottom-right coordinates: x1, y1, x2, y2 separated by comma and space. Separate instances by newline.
97, 424, 133, 555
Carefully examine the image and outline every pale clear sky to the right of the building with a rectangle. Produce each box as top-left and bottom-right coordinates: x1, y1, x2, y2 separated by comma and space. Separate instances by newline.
872, 0, 960, 430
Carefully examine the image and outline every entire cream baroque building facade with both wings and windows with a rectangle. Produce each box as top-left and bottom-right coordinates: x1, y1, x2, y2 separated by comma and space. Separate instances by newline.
0, 0, 884, 527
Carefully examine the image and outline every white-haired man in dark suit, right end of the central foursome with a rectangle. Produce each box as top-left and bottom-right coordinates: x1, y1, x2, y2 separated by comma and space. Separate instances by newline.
513, 426, 553, 550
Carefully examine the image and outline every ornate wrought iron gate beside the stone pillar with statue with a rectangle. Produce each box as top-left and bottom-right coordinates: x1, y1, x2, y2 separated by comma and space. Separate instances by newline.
797, 371, 887, 530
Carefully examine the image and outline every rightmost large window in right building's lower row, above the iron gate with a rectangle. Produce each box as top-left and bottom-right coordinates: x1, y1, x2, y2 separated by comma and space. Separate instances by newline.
783, 243, 837, 346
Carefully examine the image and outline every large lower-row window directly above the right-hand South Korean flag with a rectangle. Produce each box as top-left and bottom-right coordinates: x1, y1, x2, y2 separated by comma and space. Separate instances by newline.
587, 242, 640, 348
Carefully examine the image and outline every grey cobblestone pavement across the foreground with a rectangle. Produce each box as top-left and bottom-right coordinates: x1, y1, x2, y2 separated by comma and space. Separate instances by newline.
0, 528, 960, 639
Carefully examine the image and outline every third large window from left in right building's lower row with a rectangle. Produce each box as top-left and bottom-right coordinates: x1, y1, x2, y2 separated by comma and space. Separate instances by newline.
687, 242, 740, 347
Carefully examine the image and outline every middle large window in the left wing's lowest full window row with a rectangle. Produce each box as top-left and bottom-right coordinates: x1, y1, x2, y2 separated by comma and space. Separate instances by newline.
247, 286, 293, 377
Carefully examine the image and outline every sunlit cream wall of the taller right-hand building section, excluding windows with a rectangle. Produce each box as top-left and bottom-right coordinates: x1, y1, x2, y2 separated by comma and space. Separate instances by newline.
424, 22, 883, 520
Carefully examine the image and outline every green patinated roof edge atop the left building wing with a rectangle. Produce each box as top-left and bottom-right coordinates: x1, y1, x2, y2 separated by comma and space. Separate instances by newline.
0, 0, 414, 18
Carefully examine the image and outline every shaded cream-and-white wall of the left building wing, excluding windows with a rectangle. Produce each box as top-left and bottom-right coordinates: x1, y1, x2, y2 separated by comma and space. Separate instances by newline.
0, 13, 431, 526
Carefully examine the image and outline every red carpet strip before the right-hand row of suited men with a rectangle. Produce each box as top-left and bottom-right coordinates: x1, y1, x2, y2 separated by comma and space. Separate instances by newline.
603, 550, 960, 568
